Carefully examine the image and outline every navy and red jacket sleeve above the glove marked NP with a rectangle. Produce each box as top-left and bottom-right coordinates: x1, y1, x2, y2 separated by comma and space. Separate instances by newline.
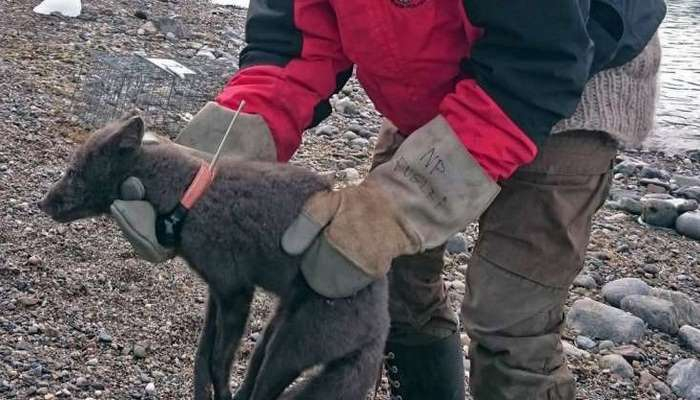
440, 0, 594, 179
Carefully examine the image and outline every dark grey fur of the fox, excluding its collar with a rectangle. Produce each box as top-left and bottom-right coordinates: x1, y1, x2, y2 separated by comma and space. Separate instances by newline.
39, 116, 389, 400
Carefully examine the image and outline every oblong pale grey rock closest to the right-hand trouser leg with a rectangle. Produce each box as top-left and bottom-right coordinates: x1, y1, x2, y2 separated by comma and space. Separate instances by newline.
566, 298, 646, 343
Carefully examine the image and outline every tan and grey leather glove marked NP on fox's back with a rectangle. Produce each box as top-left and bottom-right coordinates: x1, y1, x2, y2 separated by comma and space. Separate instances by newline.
282, 116, 500, 298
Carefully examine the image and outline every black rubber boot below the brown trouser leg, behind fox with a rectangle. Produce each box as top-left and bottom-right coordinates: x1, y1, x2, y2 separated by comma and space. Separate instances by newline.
385, 333, 465, 400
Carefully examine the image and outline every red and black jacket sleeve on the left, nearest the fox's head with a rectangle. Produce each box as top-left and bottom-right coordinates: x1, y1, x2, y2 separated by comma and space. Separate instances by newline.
216, 0, 352, 161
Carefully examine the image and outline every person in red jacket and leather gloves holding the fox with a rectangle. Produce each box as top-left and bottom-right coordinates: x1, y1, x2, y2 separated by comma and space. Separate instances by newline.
110, 0, 665, 400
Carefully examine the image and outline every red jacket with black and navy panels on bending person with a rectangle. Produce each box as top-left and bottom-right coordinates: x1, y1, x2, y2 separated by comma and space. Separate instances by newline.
217, 0, 660, 179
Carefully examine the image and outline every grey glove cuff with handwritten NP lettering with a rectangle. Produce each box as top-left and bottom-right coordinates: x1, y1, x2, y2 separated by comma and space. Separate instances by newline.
367, 116, 500, 251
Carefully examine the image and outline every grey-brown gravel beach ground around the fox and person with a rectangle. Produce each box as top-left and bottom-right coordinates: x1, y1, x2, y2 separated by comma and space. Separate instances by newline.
0, 0, 700, 399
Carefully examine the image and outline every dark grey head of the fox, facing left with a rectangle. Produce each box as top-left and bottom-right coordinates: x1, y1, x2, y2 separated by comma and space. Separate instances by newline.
38, 114, 144, 222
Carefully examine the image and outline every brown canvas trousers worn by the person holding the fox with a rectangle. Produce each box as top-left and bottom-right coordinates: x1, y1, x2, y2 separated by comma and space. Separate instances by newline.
373, 120, 616, 400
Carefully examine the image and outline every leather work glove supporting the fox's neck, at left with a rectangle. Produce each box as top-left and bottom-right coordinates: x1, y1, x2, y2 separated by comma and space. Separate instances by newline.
110, 102, 277, 263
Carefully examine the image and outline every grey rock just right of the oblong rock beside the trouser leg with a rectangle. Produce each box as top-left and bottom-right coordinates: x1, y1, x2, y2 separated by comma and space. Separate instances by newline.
620, 294, 679, 335
